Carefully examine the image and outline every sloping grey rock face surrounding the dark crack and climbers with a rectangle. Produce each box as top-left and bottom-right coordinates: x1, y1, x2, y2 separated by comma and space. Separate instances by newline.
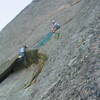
0, 0, 100, 100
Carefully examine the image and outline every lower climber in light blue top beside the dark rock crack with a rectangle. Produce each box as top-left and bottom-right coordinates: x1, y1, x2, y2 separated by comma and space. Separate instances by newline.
18, 45, 27, 62
